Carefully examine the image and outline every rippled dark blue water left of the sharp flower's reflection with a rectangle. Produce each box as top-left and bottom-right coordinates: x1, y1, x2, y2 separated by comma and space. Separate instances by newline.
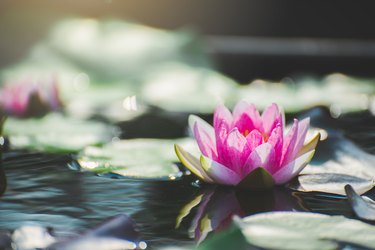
0, 151, 197, 247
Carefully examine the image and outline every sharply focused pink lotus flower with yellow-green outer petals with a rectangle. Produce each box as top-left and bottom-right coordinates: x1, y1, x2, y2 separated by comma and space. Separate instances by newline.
175, 101, 320, 188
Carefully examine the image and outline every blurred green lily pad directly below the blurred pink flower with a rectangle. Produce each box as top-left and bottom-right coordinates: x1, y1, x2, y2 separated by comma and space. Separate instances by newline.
4, 114, 116, 153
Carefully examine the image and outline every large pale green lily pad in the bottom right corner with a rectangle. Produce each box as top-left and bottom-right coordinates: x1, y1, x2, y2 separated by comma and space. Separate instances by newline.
237, 212, 375, 250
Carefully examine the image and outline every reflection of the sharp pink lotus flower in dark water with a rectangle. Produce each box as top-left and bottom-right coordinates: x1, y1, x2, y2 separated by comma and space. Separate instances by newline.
176, 186, 300, 243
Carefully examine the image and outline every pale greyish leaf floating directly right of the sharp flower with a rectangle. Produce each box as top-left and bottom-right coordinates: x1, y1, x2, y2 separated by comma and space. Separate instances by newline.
289, 136, 375, 195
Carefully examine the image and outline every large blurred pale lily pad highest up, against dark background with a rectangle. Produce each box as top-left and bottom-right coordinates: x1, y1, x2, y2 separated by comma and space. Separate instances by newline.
45, 19, 210, 80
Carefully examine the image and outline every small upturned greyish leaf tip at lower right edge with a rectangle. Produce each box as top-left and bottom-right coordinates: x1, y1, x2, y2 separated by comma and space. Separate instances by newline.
345, 185, 375, 221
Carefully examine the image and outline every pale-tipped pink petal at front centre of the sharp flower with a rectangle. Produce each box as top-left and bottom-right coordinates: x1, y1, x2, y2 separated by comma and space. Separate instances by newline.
243, 143, 275, 176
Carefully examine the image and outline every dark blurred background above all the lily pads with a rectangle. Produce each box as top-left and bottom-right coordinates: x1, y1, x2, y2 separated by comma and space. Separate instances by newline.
0, 0, 375, 82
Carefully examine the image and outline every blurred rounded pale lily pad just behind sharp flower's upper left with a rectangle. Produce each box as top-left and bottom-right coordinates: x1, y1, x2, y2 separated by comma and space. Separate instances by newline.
141, 63, 238, 113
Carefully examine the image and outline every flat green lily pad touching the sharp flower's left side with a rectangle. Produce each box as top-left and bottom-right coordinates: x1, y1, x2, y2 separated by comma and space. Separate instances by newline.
78, 138, 198, 180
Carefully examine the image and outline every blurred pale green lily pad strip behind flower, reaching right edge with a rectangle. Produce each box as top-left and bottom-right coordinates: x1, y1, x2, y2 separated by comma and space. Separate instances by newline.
239, 74, 375, 113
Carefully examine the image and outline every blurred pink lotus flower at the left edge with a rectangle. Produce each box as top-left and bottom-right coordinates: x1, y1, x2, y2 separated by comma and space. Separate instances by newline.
0, 77, 61, 117
